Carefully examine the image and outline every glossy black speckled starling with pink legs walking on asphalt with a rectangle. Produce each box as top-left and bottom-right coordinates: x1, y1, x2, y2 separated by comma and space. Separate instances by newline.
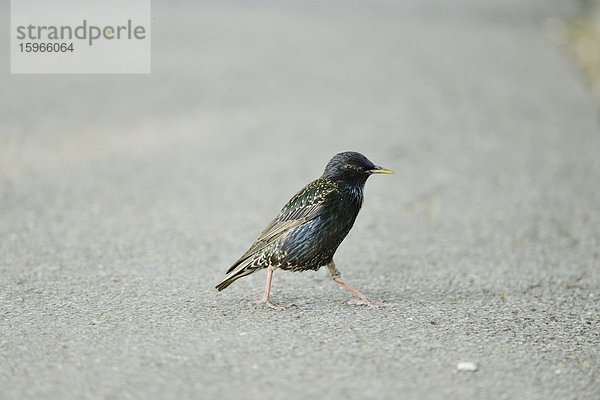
216, 151, 394, 308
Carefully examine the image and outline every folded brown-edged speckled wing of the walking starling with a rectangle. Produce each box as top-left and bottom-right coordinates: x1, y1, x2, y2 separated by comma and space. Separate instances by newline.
227, 179, 336, 272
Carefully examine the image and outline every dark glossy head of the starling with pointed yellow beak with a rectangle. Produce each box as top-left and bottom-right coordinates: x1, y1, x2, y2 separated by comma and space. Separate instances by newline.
323, 151, 394, 184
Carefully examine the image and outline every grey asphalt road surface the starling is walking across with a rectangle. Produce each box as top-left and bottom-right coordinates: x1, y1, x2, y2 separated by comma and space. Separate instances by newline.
0, 0, 600, 400
